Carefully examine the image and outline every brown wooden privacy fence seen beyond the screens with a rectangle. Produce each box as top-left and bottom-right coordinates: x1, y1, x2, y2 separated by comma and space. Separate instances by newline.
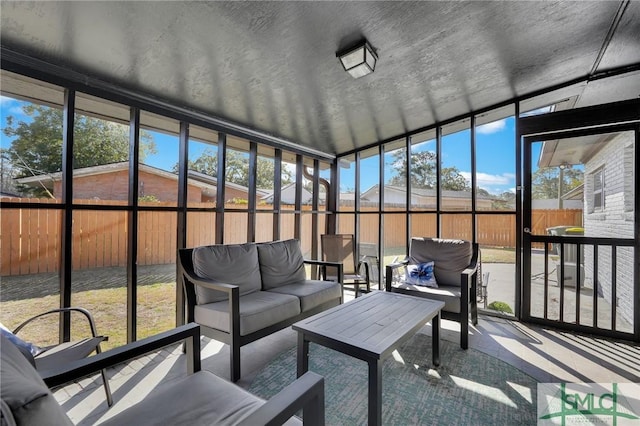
0, 199, 582, 276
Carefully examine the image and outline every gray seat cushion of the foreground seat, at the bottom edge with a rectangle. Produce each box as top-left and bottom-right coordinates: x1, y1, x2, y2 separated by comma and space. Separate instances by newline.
101, 371, 301, 425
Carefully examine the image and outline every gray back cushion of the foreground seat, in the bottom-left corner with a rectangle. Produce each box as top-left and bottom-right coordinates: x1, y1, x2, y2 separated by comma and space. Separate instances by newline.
0, 336, 73, 425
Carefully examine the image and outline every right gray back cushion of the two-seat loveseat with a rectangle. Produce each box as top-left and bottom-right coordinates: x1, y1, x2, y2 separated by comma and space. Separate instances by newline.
258, 239, 307, 290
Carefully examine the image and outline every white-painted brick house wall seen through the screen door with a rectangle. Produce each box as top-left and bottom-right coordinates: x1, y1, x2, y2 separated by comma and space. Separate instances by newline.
584, 132, 635, 324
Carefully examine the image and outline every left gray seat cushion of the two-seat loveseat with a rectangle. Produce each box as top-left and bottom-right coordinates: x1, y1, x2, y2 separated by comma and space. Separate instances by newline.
194, 291, 300, 336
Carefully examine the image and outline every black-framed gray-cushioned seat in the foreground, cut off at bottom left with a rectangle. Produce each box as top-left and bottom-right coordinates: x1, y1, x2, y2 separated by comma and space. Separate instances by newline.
0, 324, 324, 426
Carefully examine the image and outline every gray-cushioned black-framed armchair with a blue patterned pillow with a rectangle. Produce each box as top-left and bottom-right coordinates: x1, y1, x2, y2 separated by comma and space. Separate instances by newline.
385, 237, 480, 349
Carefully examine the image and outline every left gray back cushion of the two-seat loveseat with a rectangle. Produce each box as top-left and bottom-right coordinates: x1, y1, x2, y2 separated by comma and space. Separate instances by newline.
192, 243, 261, 305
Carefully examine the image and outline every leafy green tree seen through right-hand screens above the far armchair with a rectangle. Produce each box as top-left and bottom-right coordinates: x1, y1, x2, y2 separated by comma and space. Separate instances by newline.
389, 150, 471, 191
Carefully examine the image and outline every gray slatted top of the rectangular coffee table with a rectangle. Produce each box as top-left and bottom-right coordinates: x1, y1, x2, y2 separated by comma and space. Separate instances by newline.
292, 291, 444, 359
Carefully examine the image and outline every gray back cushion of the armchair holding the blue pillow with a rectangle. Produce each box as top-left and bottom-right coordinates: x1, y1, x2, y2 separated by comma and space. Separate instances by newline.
409, 237, 473, 287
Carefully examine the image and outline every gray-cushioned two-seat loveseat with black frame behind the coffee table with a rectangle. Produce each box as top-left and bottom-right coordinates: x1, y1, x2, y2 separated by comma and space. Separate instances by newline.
178, 239, 344, 382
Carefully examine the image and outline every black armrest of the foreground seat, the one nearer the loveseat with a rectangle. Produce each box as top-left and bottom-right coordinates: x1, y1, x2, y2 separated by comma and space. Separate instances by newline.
39, 323, 201, 387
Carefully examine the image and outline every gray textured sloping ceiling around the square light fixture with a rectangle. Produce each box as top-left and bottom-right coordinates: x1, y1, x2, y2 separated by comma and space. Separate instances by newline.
0, 1, 640, 154
